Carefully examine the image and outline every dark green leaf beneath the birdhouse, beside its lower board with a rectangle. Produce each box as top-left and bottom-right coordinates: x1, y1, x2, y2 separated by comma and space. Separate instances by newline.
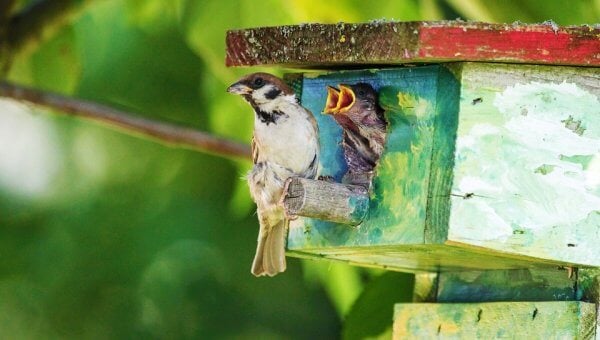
342, 272, 414, 340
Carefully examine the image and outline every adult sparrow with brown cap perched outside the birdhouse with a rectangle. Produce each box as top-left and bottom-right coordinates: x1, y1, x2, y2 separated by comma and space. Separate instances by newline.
227, 73, 319, 276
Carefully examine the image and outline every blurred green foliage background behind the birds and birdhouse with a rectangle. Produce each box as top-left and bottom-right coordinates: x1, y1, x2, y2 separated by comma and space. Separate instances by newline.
0, 0, 600, 339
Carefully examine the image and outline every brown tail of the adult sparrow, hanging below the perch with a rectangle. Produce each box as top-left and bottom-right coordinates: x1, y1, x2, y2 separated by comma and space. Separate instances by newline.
252, 212, 287, 276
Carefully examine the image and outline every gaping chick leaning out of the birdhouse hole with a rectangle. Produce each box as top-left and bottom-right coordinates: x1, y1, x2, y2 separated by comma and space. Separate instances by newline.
323, 83, 387, 186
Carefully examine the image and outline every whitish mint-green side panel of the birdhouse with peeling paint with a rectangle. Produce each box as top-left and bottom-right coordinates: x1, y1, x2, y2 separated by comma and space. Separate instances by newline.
447, 63, 600, 266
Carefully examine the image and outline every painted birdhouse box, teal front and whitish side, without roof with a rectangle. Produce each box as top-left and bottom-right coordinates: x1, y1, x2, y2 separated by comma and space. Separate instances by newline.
288, 63, 600, 272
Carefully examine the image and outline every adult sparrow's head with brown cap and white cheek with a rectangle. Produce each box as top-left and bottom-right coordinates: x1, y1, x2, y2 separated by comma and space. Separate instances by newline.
227, 72, 296, 108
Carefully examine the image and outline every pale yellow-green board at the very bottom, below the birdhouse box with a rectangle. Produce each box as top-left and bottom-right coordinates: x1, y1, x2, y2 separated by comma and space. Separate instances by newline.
393, 301, 596, 340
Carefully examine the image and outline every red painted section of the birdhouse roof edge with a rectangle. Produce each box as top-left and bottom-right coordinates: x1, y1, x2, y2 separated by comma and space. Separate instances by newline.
417, 24, 600, 66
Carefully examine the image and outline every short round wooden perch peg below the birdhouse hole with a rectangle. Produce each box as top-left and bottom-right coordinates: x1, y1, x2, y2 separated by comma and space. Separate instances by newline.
282, 177, 369, 225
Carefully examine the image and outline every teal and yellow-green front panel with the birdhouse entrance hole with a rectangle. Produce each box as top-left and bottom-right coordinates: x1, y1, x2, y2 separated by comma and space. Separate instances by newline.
288, 66, 458, 250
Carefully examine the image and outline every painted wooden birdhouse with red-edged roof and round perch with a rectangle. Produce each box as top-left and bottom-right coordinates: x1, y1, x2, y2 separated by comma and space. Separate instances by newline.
226, 22, 600, 338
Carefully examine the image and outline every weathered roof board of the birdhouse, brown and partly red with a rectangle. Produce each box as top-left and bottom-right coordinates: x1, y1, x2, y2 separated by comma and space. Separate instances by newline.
225, 21, 600, 68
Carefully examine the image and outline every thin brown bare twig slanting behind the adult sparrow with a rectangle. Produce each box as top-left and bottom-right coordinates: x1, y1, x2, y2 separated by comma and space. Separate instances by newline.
0, 82, 250, 159
